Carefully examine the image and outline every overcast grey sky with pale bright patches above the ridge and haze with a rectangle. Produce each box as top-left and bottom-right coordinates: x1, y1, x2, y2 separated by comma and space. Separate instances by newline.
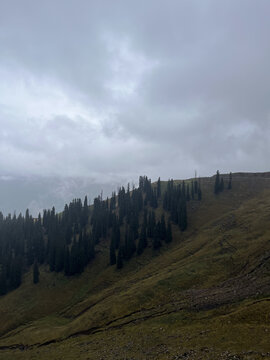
0, 0, 270, 186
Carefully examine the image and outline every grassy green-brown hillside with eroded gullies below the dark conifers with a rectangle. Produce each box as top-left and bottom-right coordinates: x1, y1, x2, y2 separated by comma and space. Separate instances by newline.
0, 173, 270, 360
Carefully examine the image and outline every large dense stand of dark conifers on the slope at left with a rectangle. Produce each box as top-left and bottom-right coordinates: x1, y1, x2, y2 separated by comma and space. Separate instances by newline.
0, 176, 210, 295
